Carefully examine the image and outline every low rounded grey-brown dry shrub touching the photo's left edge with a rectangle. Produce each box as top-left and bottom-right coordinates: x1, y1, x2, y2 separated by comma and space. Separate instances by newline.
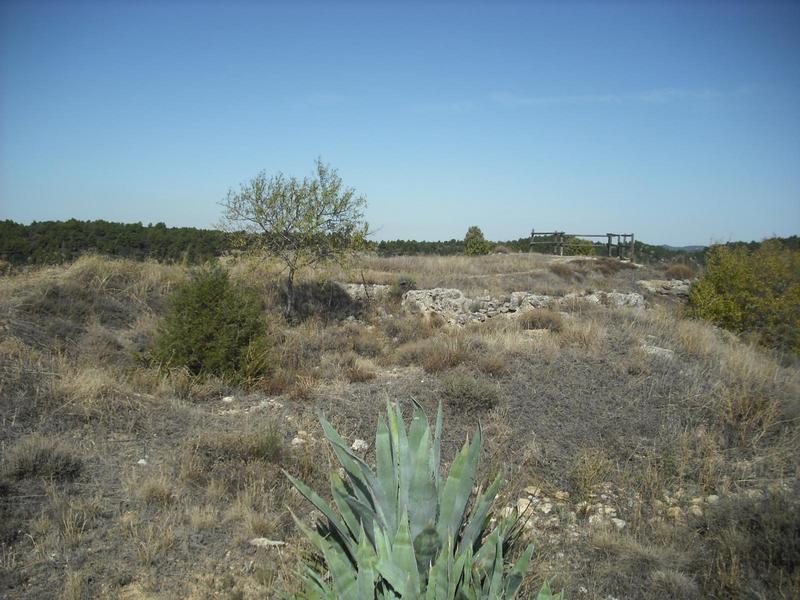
5, 434, 83, 481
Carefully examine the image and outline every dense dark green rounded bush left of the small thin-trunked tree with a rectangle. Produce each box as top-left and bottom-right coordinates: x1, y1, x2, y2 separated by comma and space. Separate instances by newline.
150, 269, 269, 381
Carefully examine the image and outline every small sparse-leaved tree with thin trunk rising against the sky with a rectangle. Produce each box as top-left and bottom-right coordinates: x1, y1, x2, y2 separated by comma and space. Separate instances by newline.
221, 159, 368, 319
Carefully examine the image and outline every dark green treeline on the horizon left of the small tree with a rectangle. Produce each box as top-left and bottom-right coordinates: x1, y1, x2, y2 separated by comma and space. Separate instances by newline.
0, 219, 228, 265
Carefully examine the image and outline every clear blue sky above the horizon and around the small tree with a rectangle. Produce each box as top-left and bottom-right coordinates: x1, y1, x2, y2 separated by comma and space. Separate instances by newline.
0, 0, 800, 244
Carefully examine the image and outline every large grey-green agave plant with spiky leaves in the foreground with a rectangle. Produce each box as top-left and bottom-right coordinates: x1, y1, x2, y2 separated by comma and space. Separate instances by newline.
287, 403, 562, 600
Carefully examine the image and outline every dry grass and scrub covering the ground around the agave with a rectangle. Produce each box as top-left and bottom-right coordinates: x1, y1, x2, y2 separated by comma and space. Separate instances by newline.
0, 254, 800, 599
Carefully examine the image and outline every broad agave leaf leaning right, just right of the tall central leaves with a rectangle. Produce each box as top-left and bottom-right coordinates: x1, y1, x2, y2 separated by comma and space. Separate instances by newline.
437, 426, 481, 539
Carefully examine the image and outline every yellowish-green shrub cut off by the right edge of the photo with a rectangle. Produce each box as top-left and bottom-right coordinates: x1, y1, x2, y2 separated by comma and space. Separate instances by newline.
689, 240, 800, 353
